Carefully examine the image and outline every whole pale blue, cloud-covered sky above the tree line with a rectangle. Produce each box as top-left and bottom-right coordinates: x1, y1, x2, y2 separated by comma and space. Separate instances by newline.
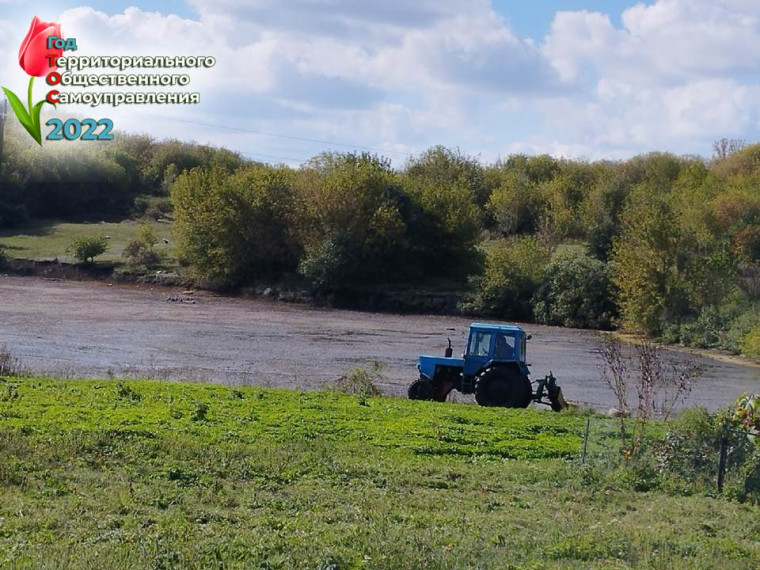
0, 0, 760, 166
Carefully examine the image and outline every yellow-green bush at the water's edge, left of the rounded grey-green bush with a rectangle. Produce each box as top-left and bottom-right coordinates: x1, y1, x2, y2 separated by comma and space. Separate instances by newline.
471, 233, 549, 320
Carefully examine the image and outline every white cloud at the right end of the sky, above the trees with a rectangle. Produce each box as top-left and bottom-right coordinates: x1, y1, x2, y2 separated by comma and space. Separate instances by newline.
534, 0, 760, 154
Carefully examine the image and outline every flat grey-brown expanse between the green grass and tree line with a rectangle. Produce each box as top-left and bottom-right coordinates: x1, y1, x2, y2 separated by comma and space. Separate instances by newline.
0, 276, 760, 410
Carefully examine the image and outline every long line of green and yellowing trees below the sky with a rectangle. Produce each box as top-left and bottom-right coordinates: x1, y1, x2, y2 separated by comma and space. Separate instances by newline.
0, 122, 760, 356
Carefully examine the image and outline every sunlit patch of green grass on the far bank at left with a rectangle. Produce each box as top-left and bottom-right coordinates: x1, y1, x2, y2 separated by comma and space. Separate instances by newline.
0, 220, 173, 262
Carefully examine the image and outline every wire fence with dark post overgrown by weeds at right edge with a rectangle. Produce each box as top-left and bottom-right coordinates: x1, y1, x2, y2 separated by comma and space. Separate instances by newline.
580, 416, 760, 496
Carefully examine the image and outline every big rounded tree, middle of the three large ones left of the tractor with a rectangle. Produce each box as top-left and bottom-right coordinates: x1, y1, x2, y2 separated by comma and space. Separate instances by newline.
297, 153, 412, 292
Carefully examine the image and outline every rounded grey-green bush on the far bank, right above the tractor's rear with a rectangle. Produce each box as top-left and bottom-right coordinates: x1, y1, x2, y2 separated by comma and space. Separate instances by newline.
533, 253, 615, 329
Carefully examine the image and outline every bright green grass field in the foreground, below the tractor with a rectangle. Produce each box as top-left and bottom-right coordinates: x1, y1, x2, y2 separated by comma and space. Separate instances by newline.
0, 379, 760, 569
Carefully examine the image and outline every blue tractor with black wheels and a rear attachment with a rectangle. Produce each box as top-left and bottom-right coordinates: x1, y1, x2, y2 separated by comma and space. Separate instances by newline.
409, 323, 567, 411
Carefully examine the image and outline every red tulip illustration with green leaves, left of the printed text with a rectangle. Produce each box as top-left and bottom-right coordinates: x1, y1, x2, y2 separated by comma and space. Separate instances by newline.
3, 16, 63, 145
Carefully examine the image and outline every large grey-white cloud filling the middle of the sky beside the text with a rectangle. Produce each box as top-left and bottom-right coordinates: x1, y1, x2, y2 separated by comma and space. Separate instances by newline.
43, 0, 557, 162
